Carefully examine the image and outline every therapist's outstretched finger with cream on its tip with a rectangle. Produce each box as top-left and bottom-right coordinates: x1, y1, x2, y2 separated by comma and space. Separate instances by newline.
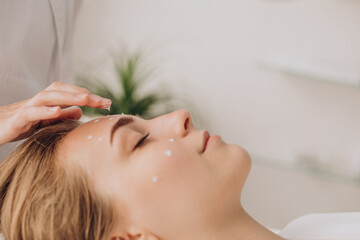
27, 90, 111, 108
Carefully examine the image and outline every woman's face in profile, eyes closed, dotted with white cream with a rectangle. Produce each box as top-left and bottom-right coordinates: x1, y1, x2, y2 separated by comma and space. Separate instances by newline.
61, 110, 251, 236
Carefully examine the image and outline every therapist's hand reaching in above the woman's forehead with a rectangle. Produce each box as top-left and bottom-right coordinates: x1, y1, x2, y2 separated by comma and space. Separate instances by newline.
0, 82, 111, 146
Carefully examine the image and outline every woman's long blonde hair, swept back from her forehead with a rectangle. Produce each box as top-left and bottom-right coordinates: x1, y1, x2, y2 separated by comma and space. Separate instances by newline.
0, 121, 113, 240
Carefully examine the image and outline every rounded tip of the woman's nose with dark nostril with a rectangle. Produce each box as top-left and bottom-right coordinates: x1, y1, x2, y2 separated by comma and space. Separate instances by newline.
170, 110, 192, 137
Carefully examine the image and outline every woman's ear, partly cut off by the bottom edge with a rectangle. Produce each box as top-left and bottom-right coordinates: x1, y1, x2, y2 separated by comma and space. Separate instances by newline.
110, 227, 161, 240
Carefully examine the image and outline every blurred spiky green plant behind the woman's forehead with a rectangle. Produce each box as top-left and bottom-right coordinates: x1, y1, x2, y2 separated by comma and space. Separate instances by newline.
76, 53, 172, 119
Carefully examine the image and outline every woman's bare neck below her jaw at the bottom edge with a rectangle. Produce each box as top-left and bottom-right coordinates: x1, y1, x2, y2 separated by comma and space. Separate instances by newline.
181, 205, 285, 240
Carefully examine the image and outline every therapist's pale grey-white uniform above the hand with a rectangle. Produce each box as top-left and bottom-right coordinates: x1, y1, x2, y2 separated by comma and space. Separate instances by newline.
0, 0, 82, 160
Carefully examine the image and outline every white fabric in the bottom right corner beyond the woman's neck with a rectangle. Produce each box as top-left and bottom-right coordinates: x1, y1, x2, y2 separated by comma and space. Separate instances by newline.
279, 212, 360, 240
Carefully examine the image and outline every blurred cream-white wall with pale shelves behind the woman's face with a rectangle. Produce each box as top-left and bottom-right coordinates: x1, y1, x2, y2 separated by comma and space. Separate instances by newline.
74, 0, 360, 231
